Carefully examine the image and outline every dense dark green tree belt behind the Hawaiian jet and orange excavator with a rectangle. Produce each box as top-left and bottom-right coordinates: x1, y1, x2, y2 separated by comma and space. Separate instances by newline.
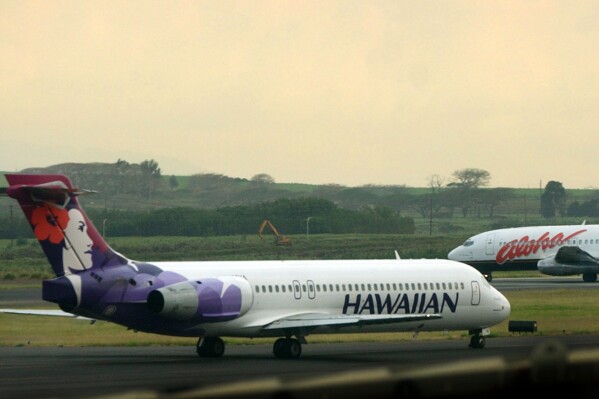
0, 198, 415, 239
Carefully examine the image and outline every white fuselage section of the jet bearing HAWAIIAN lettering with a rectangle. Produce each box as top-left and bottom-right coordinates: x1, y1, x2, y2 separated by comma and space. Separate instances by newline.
152, 259, 510, 337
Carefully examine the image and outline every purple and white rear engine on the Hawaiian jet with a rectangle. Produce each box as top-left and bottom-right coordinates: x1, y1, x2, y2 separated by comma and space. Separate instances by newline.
147, 276, 254, 322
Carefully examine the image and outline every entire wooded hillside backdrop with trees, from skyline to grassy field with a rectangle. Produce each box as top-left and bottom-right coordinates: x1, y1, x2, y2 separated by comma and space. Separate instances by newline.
0, 159, 599, 238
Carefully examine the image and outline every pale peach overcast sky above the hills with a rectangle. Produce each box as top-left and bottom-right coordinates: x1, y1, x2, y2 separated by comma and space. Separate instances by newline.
0, 0, 599, 189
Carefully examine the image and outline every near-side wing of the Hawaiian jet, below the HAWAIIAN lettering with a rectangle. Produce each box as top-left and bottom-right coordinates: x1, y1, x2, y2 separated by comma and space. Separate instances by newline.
264, 313, 441, 330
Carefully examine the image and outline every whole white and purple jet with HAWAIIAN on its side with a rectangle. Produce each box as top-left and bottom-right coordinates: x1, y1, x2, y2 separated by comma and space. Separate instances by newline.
2, 174, 510, 358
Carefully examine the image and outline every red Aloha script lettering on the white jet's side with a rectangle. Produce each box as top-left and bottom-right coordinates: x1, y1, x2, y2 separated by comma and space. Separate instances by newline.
495, 229, 587, 265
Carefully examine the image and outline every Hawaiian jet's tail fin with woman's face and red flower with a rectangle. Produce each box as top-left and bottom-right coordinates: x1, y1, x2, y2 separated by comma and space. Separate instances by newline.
5, 174, 127, 276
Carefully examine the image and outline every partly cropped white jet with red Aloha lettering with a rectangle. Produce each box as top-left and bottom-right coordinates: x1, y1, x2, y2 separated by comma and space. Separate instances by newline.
447, 223, 599, 282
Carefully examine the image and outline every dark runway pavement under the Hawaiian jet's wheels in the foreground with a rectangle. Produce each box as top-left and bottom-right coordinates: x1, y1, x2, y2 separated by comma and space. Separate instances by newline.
0, 335, 599, 399
